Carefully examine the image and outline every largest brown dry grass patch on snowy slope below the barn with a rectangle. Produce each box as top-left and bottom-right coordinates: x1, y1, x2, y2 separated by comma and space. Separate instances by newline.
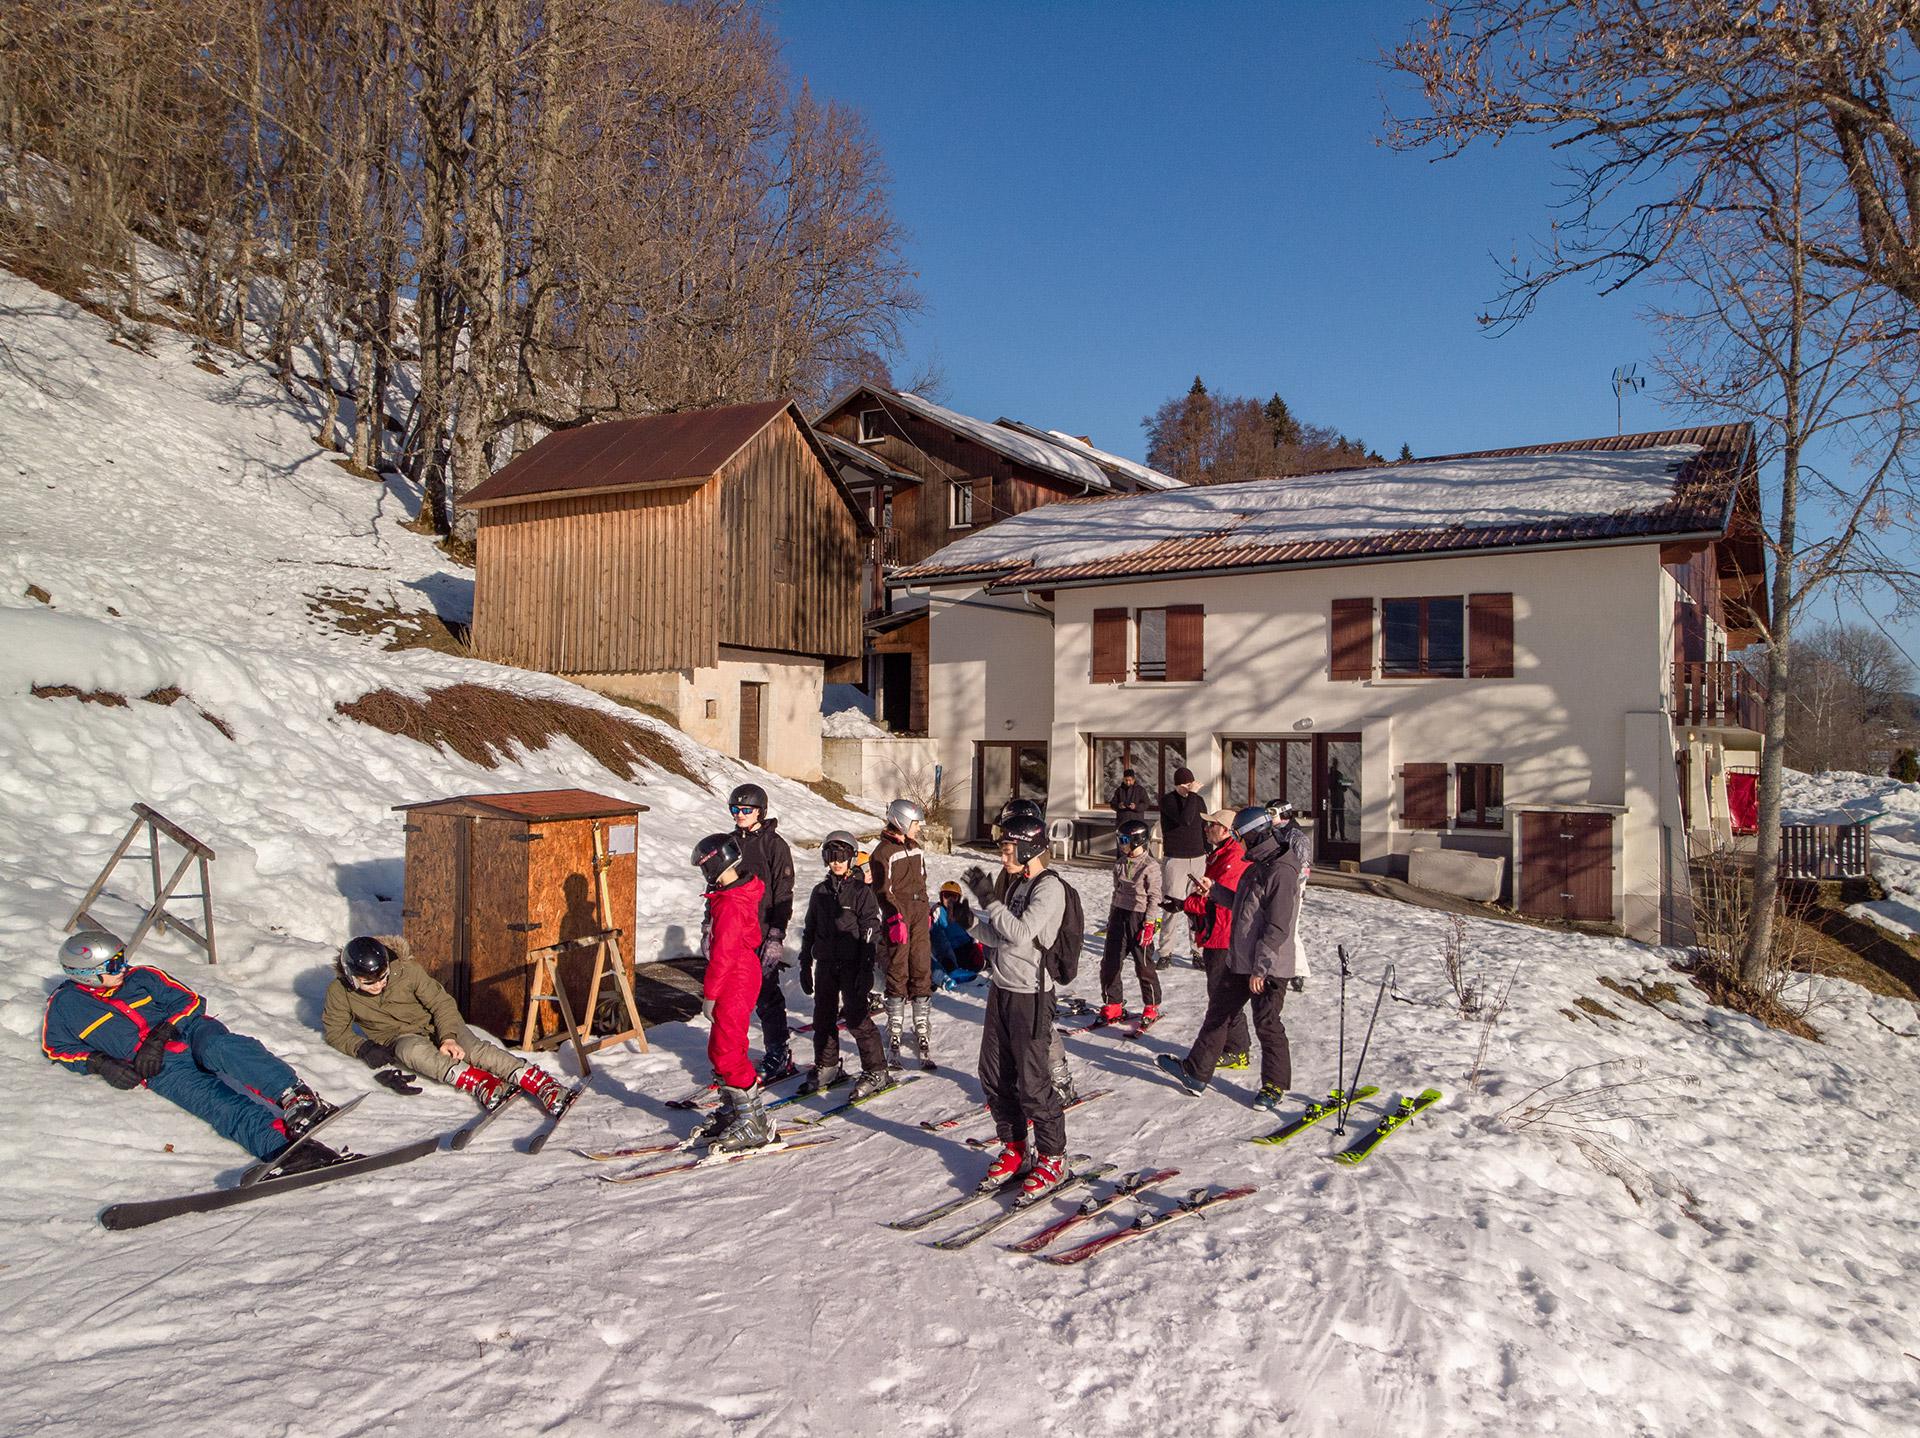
334, 683, 699, 783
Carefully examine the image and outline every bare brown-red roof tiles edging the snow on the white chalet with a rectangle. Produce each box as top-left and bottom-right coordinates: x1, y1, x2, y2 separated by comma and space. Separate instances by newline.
889, 424, 1759, 589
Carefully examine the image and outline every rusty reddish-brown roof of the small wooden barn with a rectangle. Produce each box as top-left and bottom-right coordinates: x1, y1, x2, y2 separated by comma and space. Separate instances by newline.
461, 399, 787, 505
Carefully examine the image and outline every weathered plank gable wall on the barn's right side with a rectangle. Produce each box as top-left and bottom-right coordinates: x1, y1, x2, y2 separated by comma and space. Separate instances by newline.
714, 422, 864, 657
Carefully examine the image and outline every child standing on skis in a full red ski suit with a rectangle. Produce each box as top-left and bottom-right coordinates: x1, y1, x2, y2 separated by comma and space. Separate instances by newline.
693, 833, 774, 1152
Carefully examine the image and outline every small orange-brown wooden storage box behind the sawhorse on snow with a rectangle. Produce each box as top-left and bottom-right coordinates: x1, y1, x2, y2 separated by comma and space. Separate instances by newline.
396, 789, 647, 1044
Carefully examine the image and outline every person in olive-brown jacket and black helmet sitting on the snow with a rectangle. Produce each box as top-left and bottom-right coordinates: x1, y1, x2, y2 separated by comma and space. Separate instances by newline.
321, 935, 566, 1114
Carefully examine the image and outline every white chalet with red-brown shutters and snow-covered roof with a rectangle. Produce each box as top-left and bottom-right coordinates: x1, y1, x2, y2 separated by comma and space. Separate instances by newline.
891, 424, 1766, 941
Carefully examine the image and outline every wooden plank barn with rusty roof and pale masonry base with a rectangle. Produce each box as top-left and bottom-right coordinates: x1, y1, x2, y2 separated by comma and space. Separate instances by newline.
463, 399, 872, 779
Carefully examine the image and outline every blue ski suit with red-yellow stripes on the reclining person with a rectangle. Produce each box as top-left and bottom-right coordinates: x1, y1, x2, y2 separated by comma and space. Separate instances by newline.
40, 966, 298, 1158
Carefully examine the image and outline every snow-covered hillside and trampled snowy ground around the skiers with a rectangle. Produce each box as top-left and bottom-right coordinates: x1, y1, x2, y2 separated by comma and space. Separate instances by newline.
0, 276, 1920, 1438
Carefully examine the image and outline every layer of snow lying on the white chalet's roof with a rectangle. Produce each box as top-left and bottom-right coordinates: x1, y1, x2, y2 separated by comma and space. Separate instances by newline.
916, 443, 1699, 572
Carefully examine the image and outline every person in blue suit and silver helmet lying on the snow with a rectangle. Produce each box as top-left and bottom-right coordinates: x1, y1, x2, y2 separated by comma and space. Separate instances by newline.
40, 929, 340, 1173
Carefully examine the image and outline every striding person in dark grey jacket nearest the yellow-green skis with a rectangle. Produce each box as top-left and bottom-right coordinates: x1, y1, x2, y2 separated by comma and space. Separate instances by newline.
1160, 804, 1311, 1108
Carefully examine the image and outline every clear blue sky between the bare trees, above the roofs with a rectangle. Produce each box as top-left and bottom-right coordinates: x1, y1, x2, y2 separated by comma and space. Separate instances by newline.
772, 0, 1670, 457
